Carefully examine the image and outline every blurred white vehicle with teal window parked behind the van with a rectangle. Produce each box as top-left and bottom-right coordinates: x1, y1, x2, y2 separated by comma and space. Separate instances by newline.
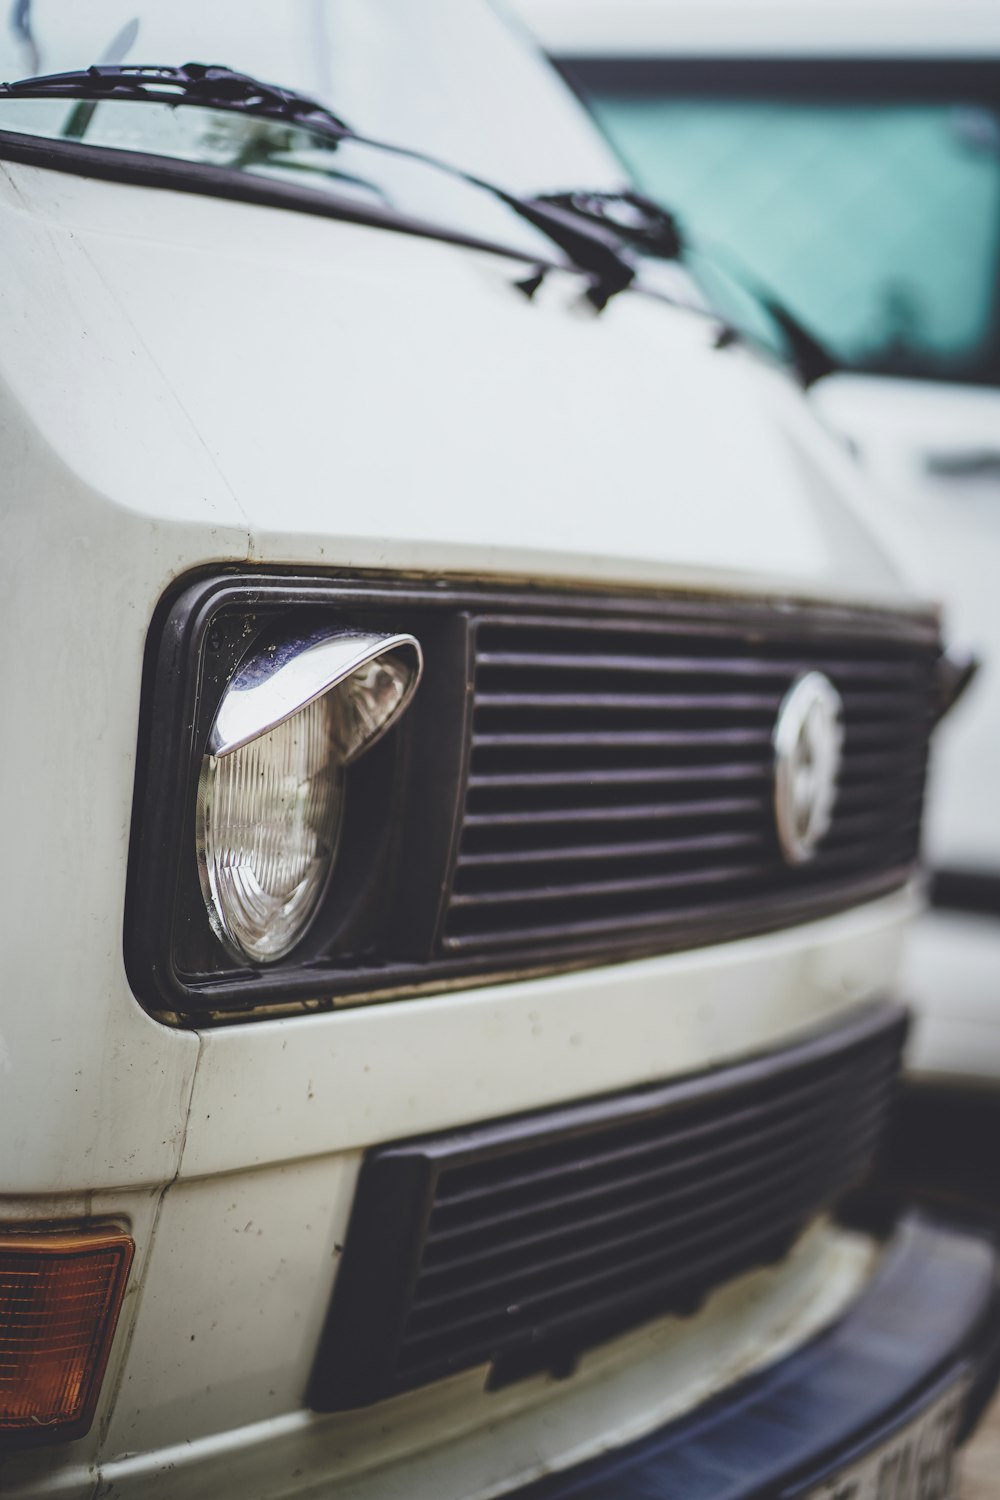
517, 0, 1000, 1083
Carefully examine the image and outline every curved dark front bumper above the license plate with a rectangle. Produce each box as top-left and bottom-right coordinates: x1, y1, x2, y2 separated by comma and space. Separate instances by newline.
511, 1215, 1000, 1500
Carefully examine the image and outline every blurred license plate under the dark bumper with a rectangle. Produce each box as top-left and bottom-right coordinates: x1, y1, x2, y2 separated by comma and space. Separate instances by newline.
801, 1382, 966, 1500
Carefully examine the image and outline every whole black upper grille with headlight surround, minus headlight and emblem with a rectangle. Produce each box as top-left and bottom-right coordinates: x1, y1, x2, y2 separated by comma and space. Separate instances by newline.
131, 570, 948, 1025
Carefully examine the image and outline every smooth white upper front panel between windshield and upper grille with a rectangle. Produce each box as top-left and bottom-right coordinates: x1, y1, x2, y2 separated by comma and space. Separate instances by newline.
0, 164, 901, 603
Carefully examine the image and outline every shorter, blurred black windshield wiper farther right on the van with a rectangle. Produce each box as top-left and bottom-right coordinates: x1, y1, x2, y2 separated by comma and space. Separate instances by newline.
541, 189, 840, 386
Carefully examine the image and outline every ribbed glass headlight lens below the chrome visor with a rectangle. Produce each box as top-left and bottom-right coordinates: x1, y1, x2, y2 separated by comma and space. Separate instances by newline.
198, 696, 343, 963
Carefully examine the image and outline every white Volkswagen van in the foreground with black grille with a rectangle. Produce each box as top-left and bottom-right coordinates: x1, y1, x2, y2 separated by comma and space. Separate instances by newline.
0, 0, 1000, 1500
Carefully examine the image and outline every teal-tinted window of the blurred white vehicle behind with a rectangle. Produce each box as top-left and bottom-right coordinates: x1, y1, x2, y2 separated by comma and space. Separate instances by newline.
565, 59, 1000, 384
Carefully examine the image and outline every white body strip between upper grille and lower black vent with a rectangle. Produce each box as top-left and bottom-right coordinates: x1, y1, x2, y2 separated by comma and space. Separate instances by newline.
180, 893, 915, 1176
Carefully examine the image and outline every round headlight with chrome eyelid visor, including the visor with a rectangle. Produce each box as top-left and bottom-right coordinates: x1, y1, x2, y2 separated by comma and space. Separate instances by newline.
196, 633, 423, 963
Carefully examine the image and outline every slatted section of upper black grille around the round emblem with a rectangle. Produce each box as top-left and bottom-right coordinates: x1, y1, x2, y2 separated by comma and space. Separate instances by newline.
442, 615, 933, 956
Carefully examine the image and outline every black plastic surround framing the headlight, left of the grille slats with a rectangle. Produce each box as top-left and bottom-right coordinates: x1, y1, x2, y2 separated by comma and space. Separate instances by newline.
124, 573, 468, 1023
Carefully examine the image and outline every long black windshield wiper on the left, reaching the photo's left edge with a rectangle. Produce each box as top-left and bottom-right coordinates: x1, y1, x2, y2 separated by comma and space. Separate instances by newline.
0, 63, 636, 311
